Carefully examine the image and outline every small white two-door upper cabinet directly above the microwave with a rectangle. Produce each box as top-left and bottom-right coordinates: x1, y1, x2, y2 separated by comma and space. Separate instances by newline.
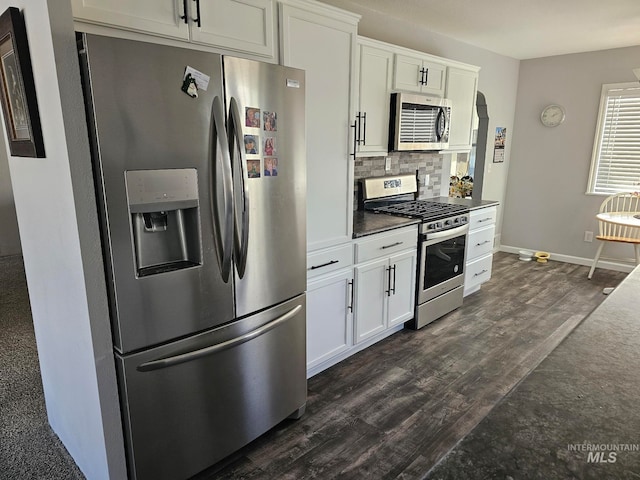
393, 54, 447, 97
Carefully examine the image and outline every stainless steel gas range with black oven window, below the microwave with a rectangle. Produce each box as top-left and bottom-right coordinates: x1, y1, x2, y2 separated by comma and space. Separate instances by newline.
362, 175, 469, 329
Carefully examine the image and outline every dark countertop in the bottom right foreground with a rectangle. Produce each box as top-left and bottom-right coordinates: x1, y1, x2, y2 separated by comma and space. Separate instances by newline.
427, 267, 640, 480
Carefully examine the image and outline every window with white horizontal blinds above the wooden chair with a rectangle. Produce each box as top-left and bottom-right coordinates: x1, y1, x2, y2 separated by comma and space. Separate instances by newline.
587, 83, 640, 195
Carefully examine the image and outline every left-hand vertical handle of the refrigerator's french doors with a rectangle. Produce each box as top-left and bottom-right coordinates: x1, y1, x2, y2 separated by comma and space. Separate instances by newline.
209, 96, 233, 283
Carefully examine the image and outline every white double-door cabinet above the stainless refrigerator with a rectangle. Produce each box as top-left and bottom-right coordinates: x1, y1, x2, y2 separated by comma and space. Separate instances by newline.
71, 0, 276, 59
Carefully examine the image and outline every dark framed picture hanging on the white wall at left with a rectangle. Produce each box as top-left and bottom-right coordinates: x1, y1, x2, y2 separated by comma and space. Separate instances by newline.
0, 7, 45, 158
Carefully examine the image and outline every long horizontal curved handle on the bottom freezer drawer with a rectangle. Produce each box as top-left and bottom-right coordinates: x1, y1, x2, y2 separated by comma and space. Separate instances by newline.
136, 305, 302, 372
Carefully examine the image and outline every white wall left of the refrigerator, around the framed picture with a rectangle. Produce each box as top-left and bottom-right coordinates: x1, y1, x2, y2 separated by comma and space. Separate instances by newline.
0, 0, 126, 479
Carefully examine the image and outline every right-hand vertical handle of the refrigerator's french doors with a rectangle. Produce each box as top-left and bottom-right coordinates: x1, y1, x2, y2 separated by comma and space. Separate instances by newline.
228, 97, 249, 278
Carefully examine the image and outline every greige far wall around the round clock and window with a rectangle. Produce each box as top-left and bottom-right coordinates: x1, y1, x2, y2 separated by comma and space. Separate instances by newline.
502, 47, 640, 263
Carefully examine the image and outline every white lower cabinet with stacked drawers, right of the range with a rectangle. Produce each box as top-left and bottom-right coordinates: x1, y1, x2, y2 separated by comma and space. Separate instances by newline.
464, 206, 498, 296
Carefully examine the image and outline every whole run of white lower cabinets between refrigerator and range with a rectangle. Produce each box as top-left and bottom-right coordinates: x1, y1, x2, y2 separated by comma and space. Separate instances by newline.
307, 226, 418, 377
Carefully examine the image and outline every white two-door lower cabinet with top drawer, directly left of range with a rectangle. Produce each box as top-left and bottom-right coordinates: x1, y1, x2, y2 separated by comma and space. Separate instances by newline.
354, 227, 418, 344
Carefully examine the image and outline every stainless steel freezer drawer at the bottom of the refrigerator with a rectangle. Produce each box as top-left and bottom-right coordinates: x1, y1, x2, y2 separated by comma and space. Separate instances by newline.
116, 295, 307, 480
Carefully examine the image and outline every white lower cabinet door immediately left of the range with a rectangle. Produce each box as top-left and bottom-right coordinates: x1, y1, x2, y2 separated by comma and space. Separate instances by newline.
388, 250, 418, 327
